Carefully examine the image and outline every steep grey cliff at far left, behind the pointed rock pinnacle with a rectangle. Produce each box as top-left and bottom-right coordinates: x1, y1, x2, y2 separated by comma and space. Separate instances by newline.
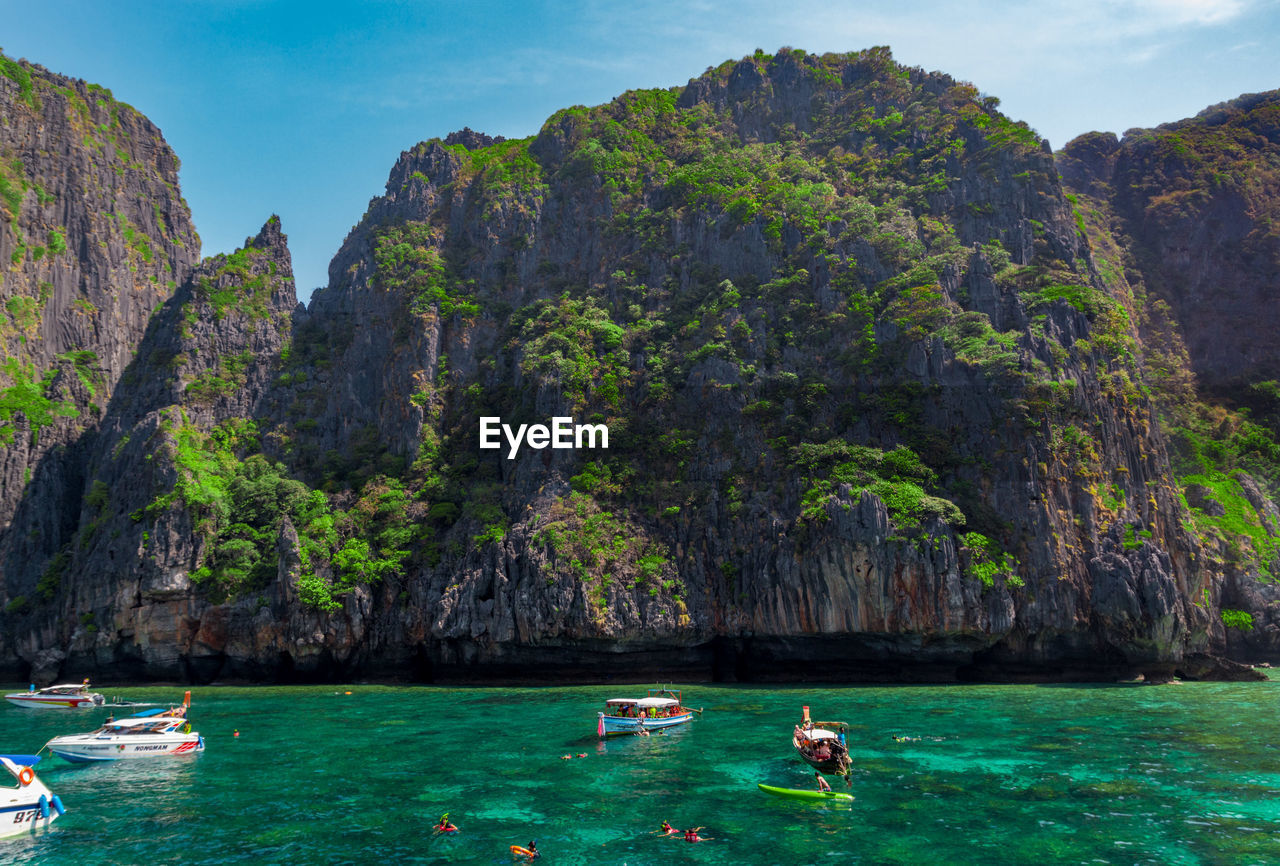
0, 56, 200, 621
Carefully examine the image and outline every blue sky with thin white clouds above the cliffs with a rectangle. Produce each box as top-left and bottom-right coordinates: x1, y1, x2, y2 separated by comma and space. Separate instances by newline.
0, 0, 1280, 298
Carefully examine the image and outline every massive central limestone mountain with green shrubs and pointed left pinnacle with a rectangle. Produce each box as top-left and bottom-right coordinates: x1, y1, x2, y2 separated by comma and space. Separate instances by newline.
0, 49, 1280, 681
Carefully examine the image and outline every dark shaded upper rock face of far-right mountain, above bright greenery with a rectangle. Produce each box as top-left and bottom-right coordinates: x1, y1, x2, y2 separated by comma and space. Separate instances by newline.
1062, 91, 1280, 391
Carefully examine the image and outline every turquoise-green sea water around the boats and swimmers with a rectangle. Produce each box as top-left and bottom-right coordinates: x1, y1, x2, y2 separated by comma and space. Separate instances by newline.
0, 682, 1280, 866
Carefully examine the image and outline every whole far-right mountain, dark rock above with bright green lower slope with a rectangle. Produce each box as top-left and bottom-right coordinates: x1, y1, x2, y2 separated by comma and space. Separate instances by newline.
1059, 91, 1280, 657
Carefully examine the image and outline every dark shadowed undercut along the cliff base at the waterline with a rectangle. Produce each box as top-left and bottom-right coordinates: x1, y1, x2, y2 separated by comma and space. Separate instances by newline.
32, 634, 1258, 686
